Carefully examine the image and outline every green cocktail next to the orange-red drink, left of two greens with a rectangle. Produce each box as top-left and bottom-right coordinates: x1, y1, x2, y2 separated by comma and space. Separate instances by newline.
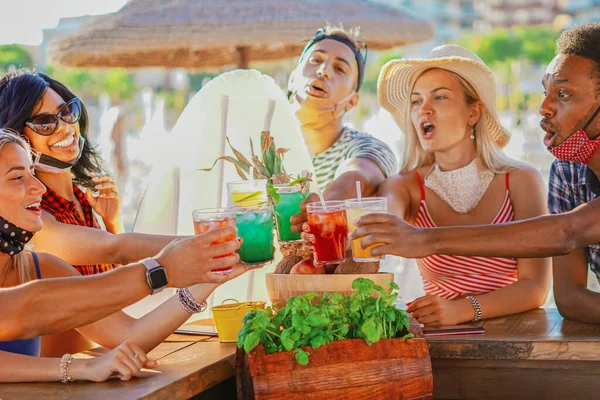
235, 203, 275, 264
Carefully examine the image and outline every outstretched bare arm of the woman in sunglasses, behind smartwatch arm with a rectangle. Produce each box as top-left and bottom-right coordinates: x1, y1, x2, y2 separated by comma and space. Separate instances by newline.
33, 212, 177, 265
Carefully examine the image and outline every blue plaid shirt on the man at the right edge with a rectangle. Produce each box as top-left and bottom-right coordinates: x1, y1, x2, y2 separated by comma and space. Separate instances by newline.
548, 160, 600, 281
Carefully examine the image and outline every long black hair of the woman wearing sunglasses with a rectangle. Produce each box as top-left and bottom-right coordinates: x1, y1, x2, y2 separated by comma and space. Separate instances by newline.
0, 69, 102, 188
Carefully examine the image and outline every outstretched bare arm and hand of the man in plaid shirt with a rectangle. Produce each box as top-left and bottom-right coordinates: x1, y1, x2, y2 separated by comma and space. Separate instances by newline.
351, 199, 600, 258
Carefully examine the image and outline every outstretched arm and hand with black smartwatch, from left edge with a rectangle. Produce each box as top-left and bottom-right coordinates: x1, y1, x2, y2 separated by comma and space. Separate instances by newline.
0, 228, 240, 340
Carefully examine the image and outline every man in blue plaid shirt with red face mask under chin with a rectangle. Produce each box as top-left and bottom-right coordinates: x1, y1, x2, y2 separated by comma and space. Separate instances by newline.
351, 23, 600, 324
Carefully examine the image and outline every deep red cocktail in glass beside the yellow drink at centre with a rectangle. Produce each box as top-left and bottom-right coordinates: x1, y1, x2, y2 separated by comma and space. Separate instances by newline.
306, 201, 348, 264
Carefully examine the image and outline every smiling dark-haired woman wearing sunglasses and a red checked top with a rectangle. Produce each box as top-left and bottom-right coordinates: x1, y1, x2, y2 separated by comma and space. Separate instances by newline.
0, 70, 166, 355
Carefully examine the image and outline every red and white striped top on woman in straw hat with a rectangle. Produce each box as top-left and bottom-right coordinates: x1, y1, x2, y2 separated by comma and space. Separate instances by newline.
415, 172, 518, 299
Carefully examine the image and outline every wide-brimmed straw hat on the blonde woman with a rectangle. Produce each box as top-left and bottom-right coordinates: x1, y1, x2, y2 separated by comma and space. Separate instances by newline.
377, 45, 510, 148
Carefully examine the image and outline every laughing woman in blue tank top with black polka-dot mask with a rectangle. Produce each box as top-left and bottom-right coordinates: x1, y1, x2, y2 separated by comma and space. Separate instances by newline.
0, 130, 254, 383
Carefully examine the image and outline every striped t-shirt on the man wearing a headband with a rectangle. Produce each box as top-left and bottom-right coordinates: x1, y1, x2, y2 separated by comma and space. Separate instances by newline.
312, 127, 398, 190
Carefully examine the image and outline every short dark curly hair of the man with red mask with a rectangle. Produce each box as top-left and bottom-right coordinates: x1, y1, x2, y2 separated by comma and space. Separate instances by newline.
556, 22, 600, 87
